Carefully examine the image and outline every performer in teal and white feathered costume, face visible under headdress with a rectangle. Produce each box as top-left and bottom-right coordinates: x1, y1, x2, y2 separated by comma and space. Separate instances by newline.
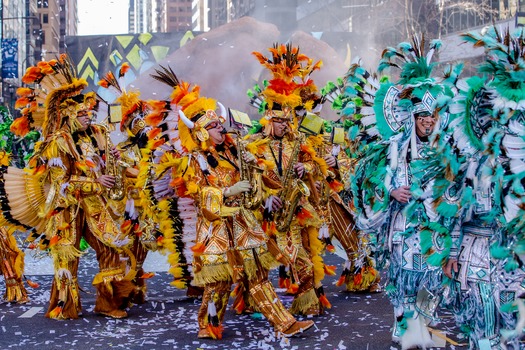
348, 37, 453, 349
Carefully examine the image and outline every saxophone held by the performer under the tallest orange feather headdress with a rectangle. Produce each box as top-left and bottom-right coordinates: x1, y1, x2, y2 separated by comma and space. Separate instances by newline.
274, 134, 310, 232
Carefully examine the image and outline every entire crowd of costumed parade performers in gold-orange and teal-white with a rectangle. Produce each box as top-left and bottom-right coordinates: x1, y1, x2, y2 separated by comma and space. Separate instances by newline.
0, 26, 525, 350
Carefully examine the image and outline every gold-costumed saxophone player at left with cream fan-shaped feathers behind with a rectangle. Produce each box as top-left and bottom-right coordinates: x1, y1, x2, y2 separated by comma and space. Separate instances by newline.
2, 55, 134, 319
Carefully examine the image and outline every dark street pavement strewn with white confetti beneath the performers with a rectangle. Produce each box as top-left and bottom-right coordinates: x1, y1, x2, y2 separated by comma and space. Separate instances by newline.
0, 250, 466, 350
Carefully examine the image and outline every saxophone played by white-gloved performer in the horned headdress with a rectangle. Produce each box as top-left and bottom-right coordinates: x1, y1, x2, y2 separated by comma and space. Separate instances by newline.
235, 131, 264, 209
